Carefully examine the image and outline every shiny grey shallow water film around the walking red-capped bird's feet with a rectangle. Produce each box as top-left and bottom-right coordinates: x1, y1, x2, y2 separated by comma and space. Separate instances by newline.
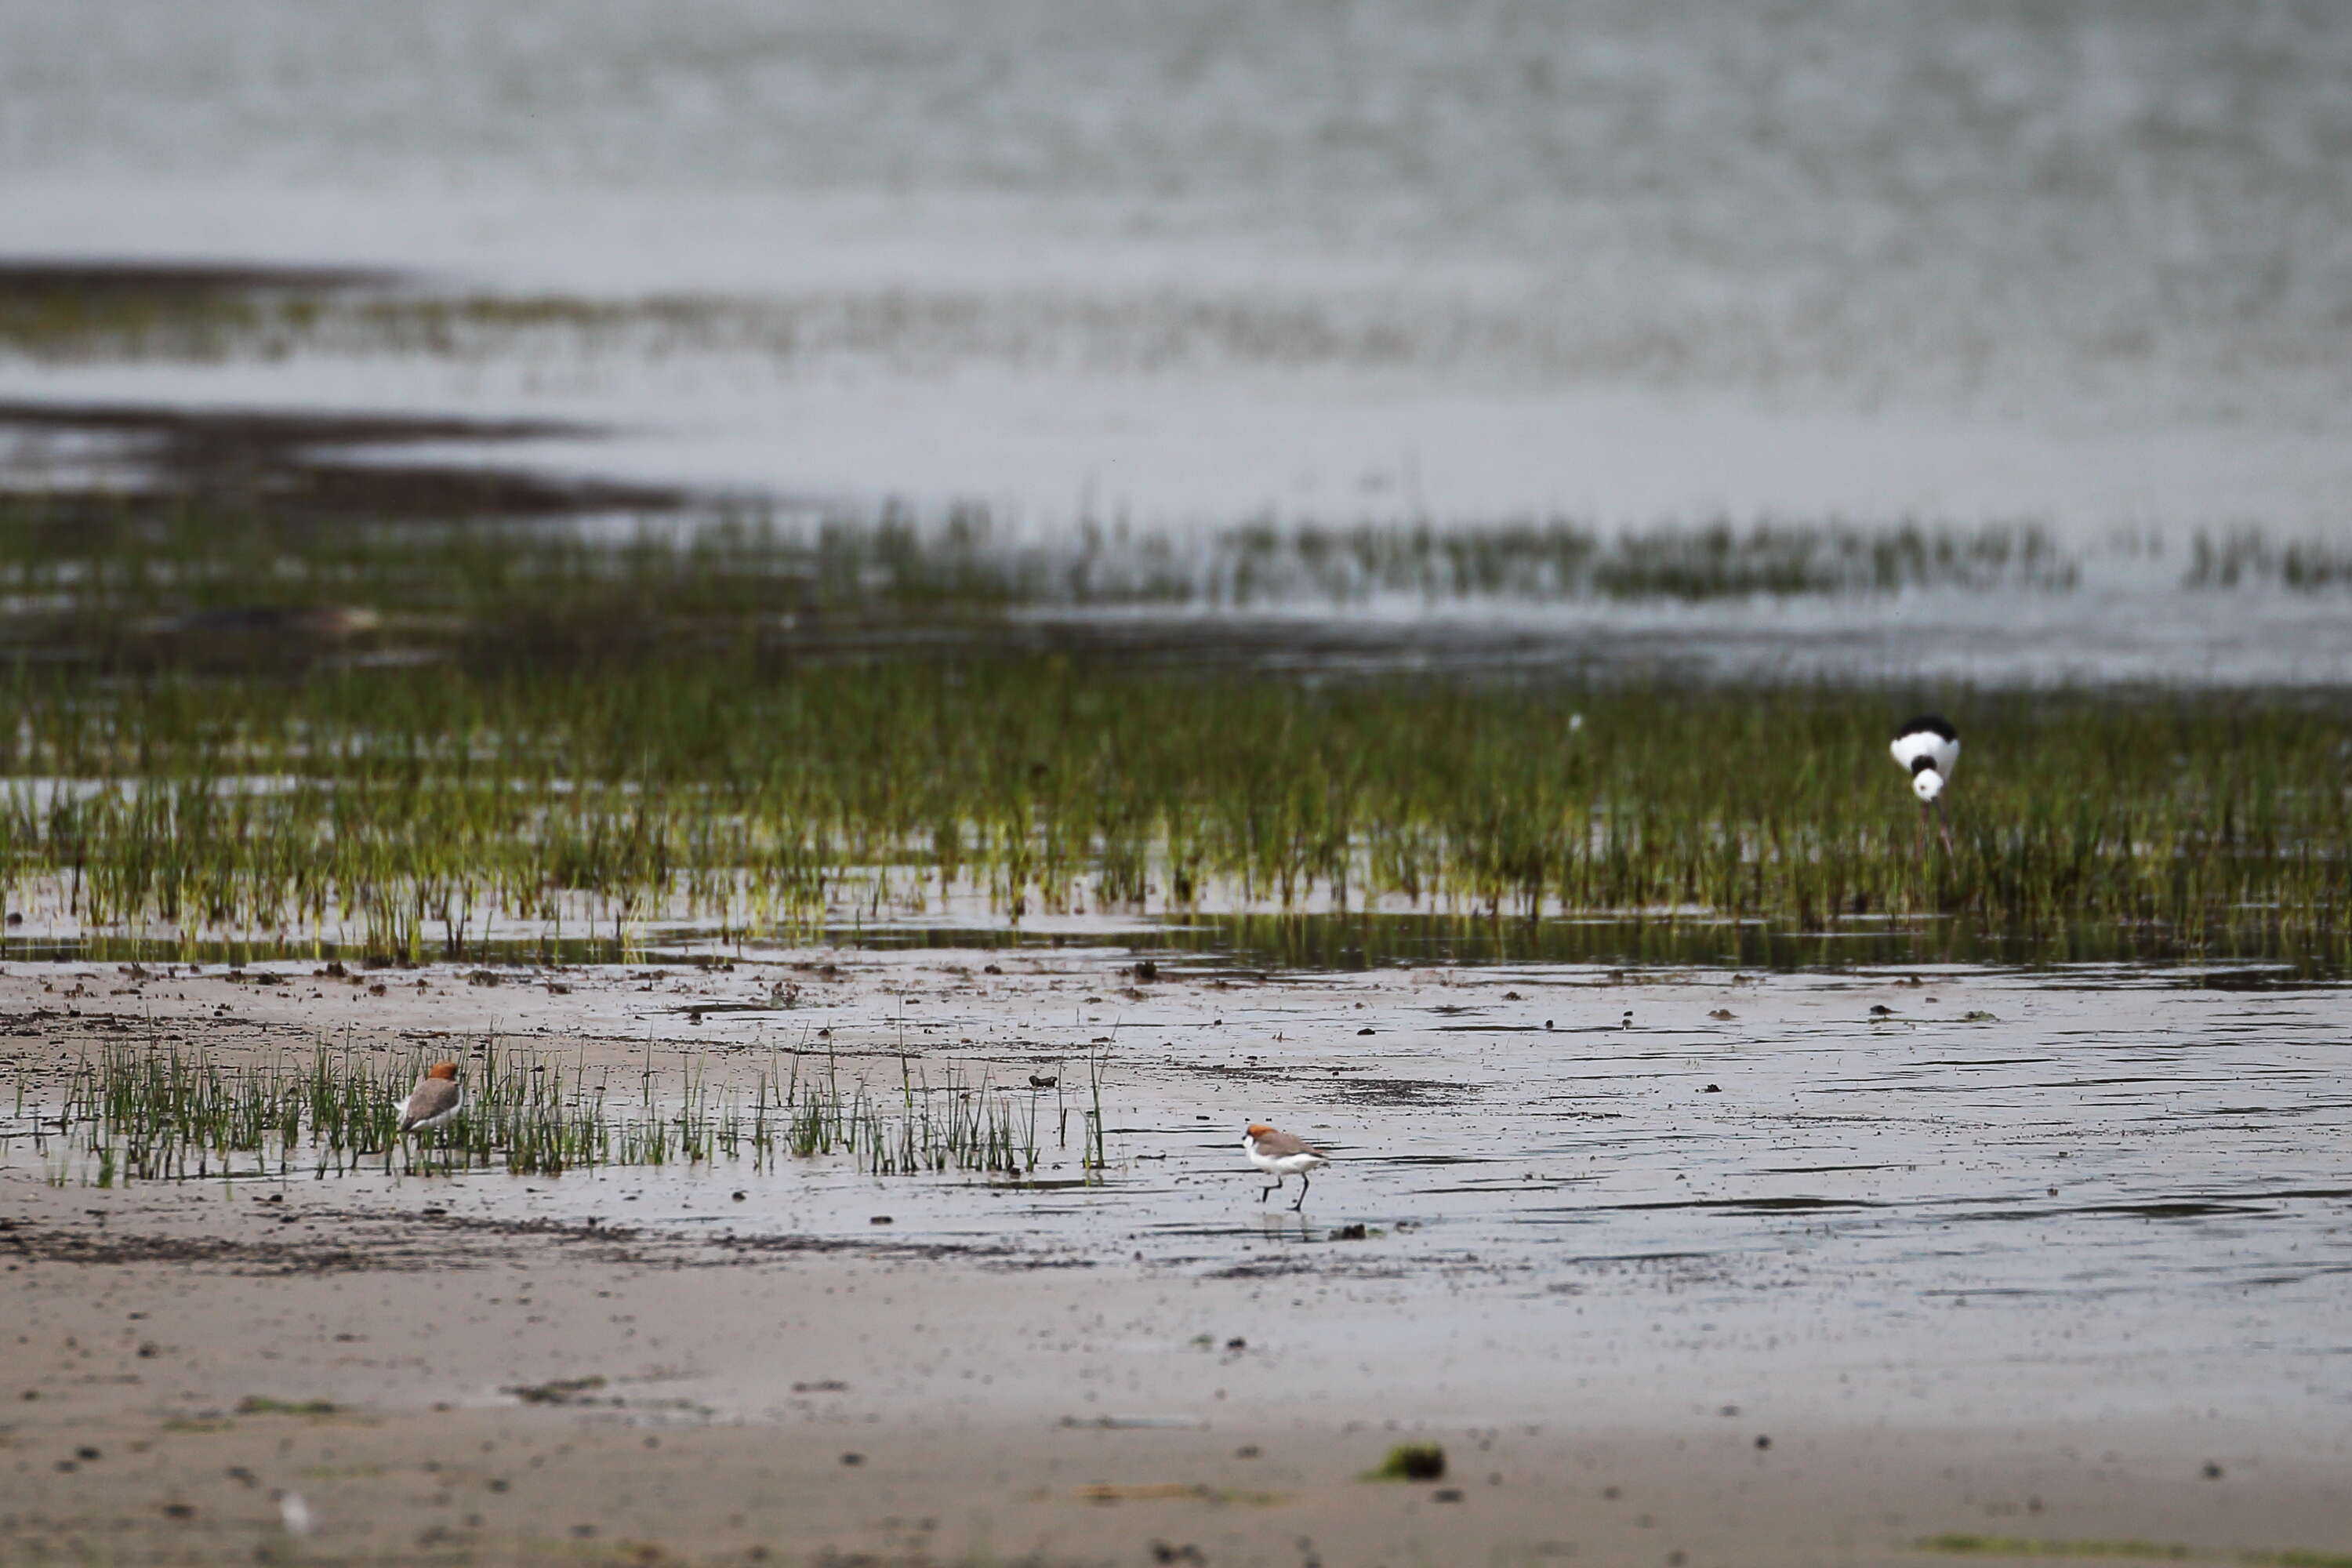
9, 952, 2352, 1425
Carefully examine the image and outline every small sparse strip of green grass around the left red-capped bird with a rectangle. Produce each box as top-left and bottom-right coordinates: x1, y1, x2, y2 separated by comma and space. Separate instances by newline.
0, 1036, 1077, 1187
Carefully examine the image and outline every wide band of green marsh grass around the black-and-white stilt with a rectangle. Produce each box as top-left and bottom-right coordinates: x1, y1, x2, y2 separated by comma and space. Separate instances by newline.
0, 499, 2352, 956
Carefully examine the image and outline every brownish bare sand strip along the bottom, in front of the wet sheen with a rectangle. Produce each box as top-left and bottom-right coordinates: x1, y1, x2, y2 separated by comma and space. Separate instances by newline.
0, 1241, 2345, 1568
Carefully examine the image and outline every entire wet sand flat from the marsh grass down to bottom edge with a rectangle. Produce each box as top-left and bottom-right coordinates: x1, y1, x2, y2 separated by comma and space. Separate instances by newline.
0, 949, 2352, 1563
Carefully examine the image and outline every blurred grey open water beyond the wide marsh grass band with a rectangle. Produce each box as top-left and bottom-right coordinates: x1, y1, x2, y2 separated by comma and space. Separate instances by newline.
0, 0, 2352, 682
